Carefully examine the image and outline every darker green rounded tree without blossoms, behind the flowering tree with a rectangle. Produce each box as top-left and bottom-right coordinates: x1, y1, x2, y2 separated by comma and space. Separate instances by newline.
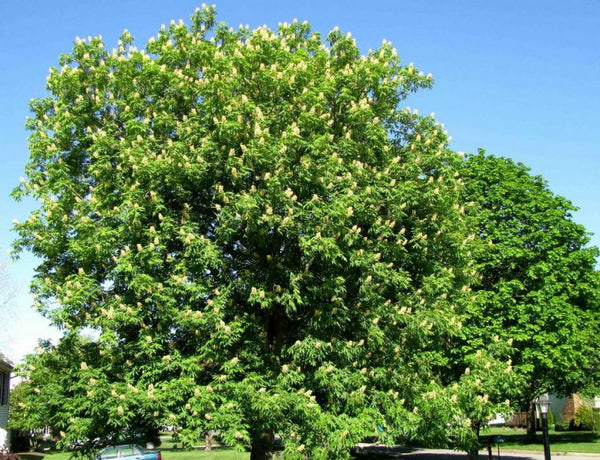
461, 151, 600, 438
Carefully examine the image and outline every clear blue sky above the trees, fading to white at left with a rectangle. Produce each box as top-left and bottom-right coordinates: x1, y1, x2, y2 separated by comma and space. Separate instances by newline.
0, 0, 600, 361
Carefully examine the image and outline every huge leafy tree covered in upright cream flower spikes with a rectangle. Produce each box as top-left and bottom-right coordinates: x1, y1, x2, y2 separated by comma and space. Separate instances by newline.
15, 7, 506, 459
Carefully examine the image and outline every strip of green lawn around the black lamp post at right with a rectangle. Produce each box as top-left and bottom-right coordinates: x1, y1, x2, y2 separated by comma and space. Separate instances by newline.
483, 427, 600, 454
